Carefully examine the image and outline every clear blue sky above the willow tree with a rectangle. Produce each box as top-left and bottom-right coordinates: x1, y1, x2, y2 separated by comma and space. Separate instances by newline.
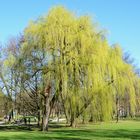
0, 0, 140, 66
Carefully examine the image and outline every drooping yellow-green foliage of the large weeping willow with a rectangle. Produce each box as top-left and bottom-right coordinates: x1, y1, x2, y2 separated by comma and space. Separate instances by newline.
22, 7, 136, 125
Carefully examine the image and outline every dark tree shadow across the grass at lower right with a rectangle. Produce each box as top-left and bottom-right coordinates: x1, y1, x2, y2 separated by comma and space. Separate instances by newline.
51, 129, 140, 140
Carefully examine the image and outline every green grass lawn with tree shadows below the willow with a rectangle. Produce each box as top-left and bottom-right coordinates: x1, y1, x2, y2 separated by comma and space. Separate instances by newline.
0, 121, 140, 140
